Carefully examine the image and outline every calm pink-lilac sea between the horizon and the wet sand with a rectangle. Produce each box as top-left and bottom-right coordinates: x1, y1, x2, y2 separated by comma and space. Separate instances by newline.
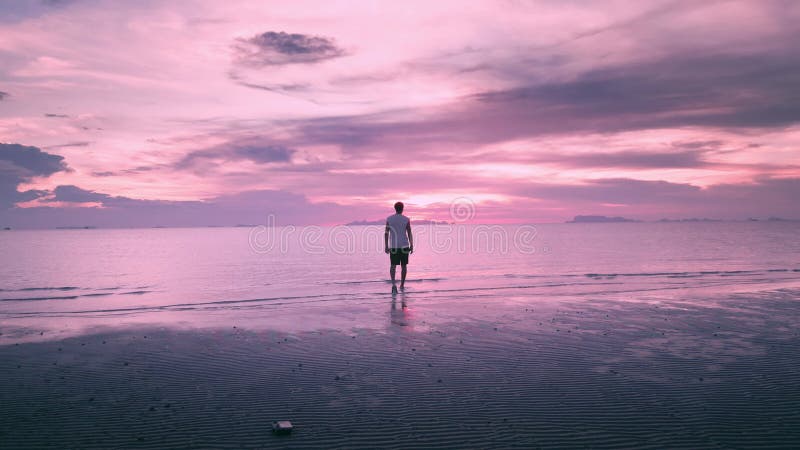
0, 221, 800, 338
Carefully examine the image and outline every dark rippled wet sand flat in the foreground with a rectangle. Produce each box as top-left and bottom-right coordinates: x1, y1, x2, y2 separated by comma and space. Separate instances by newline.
0, 289, 800, 449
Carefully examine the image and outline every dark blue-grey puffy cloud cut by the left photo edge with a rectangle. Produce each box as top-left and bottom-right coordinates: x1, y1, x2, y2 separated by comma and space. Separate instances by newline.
0, 144, 67, 209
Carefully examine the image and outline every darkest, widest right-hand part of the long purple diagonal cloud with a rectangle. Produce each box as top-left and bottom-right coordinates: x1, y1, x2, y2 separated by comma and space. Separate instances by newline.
458, 52, 800, 137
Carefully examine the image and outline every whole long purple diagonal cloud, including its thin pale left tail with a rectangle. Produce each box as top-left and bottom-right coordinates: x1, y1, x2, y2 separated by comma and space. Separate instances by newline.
284, 48, 800, 153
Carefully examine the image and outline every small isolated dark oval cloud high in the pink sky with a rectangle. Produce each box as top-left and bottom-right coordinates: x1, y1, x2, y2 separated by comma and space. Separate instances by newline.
233, 31, 345, 67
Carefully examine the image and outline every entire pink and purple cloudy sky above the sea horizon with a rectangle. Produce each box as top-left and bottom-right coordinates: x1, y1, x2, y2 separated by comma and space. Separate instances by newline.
0, 0, 800, 227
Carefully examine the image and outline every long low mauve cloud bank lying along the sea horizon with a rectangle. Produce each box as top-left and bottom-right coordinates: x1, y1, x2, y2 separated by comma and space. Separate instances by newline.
0, 174, 800, 227
